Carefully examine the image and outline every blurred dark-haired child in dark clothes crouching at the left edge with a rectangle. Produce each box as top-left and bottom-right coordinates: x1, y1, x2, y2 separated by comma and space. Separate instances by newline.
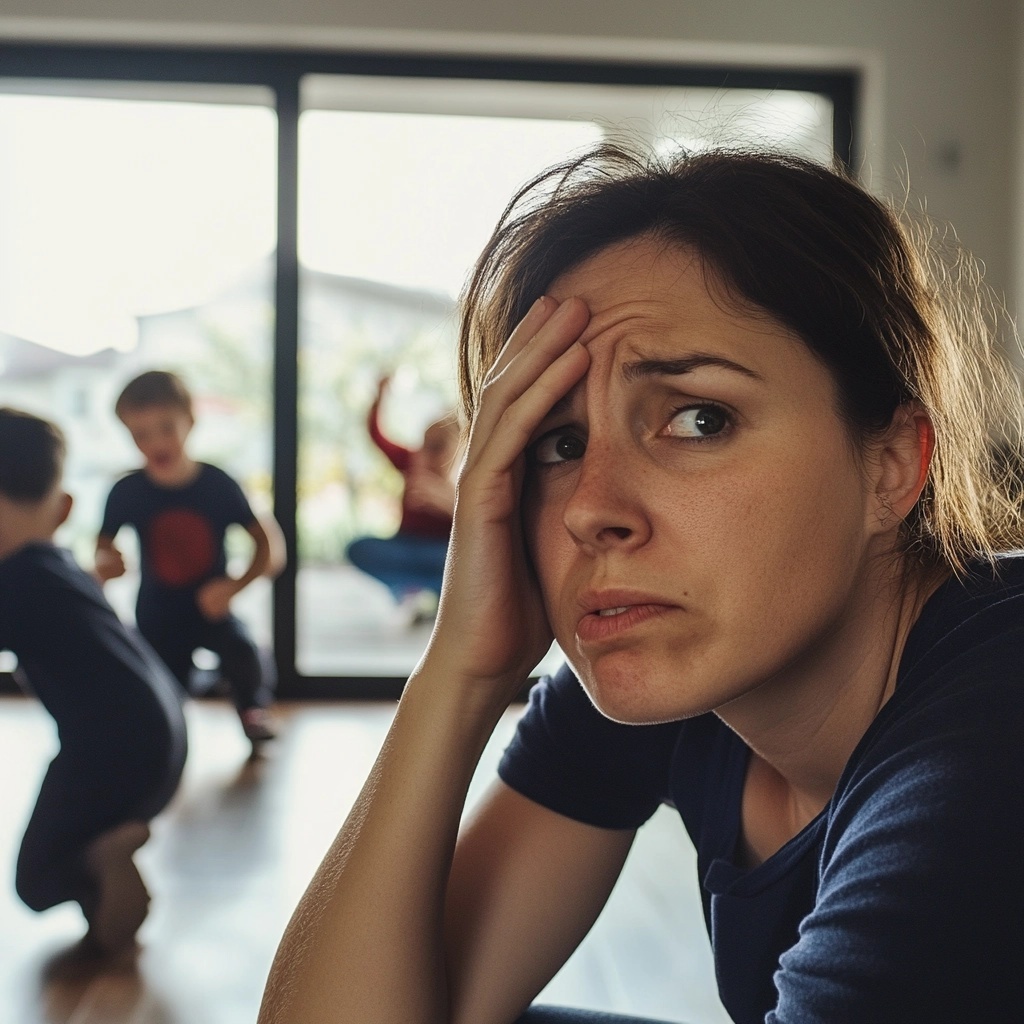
0, 409, 185, 954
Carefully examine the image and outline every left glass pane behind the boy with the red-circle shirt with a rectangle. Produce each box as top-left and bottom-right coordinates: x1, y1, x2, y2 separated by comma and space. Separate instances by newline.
0, 81, 276, 663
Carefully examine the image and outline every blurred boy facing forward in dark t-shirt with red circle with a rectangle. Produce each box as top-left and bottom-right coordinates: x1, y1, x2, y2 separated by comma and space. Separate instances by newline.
96, 370, 284, 752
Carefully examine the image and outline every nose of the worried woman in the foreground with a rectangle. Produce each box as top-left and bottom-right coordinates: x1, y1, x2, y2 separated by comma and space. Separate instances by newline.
562, 439, 650, 551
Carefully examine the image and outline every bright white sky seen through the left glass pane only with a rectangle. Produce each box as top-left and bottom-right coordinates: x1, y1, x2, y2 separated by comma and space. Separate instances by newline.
0, 95, 275, 352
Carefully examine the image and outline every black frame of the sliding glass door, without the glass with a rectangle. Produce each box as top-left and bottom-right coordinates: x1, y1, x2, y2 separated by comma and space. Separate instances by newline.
0, 43, 859, 699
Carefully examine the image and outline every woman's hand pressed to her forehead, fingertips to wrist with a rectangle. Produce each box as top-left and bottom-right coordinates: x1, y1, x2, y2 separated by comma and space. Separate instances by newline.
428, 297, 590, 707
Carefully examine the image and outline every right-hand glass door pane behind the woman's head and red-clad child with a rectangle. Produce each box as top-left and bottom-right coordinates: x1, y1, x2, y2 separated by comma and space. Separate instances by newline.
296, 76, 831, 677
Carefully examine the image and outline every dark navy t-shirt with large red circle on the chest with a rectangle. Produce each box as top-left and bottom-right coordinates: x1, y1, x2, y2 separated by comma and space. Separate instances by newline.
99, 463, 256, 608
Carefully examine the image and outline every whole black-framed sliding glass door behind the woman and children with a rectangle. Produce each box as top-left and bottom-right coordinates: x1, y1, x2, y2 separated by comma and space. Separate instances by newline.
0, 44, 856, 696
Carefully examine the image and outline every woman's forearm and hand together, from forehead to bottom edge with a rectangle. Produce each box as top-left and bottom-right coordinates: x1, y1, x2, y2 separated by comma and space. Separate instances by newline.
259, 292, 590, 1024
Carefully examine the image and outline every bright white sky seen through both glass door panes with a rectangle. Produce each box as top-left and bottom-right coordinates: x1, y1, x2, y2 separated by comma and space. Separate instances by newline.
0, 95, 598, 353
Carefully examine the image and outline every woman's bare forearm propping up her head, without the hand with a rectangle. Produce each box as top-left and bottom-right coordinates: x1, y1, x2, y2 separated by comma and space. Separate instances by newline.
259, 659, 502, 1024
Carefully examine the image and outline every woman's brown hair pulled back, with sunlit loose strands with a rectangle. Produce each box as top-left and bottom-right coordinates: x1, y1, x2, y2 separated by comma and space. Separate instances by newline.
459, 145, 1024, 570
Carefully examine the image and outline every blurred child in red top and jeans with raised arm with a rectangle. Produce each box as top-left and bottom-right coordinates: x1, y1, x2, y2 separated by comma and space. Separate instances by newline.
345, 377, 459, 621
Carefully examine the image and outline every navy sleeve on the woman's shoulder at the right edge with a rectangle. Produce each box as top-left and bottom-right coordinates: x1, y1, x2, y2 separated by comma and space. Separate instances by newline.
767, 634, 1024, 1024
